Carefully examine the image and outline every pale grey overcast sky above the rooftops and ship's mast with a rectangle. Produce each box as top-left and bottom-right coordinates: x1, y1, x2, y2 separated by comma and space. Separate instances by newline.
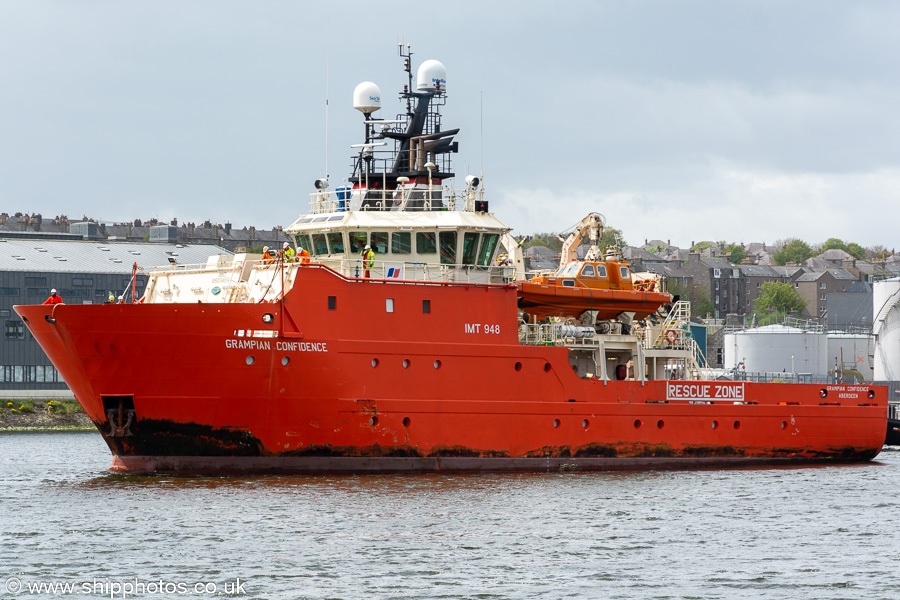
0, 0, 900, 249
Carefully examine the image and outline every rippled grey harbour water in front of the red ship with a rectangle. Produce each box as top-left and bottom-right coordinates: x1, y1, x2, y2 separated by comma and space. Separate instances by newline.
0, 433, 900, 600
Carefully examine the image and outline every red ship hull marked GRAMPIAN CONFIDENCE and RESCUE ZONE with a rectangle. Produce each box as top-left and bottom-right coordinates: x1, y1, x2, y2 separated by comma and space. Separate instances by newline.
16, 265, 887, 473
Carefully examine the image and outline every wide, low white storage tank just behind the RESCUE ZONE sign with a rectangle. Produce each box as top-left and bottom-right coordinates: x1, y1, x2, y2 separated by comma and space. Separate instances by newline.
723, 325, 828, 375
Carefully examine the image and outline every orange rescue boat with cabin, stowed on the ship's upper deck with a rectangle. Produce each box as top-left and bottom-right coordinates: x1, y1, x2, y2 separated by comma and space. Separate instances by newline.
516, 260, 672, 320
